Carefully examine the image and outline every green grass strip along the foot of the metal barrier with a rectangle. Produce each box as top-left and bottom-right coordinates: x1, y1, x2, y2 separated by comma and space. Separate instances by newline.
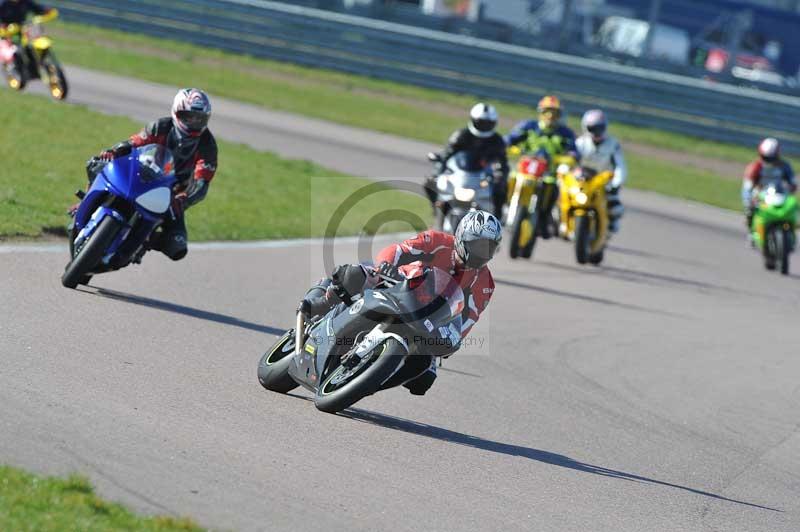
51, 22, 754, 163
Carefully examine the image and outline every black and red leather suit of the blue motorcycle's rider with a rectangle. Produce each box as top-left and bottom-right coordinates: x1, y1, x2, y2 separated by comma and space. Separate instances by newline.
87, 117, 217, 260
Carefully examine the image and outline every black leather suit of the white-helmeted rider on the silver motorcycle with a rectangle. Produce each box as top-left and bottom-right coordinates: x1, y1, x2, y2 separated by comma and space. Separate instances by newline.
425, 127, 508, 218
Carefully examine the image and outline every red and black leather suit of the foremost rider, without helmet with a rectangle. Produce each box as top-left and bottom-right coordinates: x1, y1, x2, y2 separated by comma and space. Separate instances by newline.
301, 230, 494, 395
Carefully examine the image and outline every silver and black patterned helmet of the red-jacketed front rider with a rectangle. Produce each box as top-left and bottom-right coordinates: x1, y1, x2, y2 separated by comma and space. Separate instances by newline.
455, 211, 503, 268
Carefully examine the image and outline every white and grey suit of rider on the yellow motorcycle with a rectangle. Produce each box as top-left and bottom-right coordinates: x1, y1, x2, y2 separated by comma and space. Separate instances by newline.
575, 134, 628, 233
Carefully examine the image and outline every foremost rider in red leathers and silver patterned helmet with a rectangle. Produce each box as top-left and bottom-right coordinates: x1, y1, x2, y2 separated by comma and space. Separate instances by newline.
300, 211, 502, 395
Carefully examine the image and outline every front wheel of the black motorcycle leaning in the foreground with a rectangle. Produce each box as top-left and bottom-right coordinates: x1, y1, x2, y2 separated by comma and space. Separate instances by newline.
314, 338, 406, 414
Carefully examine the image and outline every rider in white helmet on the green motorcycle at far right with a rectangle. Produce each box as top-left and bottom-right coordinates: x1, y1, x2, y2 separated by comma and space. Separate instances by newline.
742, 137, 797, 239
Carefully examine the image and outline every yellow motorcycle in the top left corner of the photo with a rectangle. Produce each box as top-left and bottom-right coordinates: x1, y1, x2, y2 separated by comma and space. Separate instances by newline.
0, 9, 69, 100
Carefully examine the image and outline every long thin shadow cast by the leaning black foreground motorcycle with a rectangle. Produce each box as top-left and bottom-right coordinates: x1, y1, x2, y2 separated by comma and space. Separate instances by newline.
338, 408, 783, 513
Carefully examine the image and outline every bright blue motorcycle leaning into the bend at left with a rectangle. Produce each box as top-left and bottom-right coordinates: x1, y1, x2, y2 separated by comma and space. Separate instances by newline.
61, 144, 177, 288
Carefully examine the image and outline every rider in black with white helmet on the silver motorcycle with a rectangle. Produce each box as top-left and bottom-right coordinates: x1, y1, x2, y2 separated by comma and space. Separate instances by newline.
424, 103, 508, 217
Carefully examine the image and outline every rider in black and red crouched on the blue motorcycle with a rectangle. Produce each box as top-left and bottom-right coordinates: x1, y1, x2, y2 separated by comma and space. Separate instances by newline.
75, 89, 217, 260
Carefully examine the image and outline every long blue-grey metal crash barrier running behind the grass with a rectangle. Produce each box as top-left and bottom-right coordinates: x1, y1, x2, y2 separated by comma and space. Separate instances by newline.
49, 0, 800, 153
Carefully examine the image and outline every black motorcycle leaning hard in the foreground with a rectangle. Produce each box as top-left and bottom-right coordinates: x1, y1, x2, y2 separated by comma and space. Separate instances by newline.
258, 268, 464, 413
